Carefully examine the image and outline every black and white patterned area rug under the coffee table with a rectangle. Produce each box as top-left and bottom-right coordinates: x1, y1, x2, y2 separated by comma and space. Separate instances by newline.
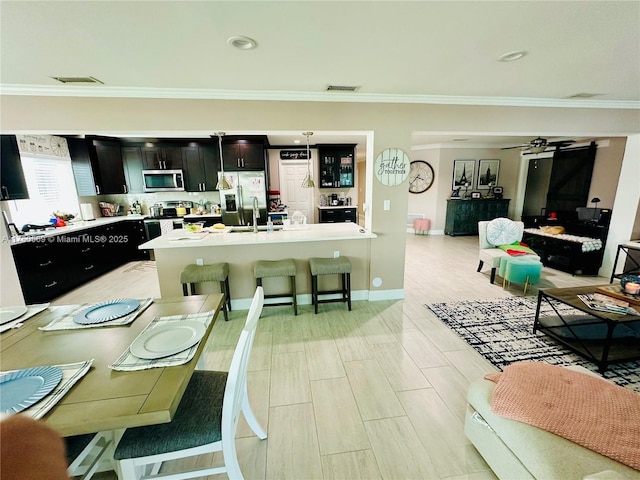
425, 297, 640, 393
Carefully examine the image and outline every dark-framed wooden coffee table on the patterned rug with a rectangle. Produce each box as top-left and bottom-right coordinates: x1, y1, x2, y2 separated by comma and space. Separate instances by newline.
533, 285, 640, 373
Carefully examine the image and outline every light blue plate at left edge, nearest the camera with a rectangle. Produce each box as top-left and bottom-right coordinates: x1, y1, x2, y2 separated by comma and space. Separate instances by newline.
0, 367, 62, 413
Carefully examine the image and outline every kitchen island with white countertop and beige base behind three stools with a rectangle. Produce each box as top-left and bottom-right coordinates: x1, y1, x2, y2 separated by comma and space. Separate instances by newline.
139, 223, 377, 309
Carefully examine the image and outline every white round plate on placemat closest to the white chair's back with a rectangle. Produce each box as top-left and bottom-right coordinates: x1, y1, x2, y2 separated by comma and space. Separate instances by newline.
129, 320, 207, 359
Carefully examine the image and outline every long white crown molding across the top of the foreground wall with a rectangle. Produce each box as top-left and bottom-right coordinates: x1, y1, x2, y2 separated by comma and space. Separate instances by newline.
0, 84, 640, 110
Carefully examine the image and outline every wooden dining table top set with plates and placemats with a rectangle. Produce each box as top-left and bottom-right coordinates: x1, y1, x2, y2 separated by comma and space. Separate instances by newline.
0, 294, 224, 436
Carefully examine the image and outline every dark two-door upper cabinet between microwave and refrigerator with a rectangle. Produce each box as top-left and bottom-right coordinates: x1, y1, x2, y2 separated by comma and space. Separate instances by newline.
182, 144, 220, 192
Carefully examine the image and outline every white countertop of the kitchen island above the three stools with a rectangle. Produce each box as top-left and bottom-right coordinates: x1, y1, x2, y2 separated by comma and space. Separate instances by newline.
138, 222, 377, 250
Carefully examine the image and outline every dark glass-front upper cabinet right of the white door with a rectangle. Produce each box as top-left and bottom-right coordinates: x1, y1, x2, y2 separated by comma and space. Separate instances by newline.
317, 144, 356, 188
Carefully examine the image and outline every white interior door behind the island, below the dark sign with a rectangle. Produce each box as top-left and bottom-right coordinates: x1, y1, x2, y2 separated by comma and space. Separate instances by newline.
280, 160, 315, 223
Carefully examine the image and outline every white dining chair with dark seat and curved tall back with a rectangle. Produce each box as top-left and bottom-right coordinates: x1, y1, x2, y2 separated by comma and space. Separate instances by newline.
114, 287, 267, 480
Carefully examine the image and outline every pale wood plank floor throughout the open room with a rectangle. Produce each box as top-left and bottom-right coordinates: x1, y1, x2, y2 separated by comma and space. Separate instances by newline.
54, 234, 608, 480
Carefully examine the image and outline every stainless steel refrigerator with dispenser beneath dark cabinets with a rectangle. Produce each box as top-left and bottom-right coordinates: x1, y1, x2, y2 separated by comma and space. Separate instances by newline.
218, 171, 267, 225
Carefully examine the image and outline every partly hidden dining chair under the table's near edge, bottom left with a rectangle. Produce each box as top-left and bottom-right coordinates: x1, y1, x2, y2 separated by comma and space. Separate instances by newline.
64, 430, 113, 480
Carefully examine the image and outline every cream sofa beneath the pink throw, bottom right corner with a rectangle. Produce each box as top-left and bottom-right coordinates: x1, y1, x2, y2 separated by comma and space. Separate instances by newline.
465, 367, 640, 480
